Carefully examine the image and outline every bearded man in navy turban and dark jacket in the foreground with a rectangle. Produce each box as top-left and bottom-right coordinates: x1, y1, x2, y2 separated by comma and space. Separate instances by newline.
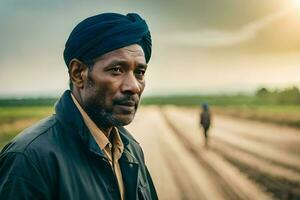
0, 13, 158, 200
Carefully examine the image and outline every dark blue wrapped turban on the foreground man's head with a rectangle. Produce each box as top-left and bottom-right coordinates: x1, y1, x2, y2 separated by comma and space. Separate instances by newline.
64, 13, 152, 67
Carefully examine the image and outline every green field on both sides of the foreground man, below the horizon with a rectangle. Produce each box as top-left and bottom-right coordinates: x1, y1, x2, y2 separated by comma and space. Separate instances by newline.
0, 95, 300, 149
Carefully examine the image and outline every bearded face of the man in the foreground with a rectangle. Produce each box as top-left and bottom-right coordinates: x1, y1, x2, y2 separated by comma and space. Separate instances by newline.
81, 44, 147, 127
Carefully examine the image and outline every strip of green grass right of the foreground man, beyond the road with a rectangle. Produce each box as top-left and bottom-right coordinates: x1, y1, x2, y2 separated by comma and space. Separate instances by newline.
142, 95, 300, 128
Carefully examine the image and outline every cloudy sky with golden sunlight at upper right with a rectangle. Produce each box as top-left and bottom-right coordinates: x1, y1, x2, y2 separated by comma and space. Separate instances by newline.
0, 0, 300, 97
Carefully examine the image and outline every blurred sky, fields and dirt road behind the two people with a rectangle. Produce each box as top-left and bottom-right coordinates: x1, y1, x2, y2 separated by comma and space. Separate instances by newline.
0, 0, 300, 199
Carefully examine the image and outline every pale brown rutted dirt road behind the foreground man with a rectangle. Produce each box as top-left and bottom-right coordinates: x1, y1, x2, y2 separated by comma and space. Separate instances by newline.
127, 107, 300, 200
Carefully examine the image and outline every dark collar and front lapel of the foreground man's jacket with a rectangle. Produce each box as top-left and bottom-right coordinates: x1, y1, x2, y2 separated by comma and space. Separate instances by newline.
55, 90, 139, 199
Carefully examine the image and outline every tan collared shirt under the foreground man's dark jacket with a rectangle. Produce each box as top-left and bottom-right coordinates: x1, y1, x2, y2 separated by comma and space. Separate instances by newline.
71, 94, 125, 200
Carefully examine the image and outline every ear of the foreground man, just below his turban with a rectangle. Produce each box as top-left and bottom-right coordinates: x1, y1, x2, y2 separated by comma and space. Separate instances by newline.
69, 58, 88, 89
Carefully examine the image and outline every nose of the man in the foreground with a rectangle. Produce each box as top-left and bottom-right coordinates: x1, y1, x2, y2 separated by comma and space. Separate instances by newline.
122, 72, 142, 94
